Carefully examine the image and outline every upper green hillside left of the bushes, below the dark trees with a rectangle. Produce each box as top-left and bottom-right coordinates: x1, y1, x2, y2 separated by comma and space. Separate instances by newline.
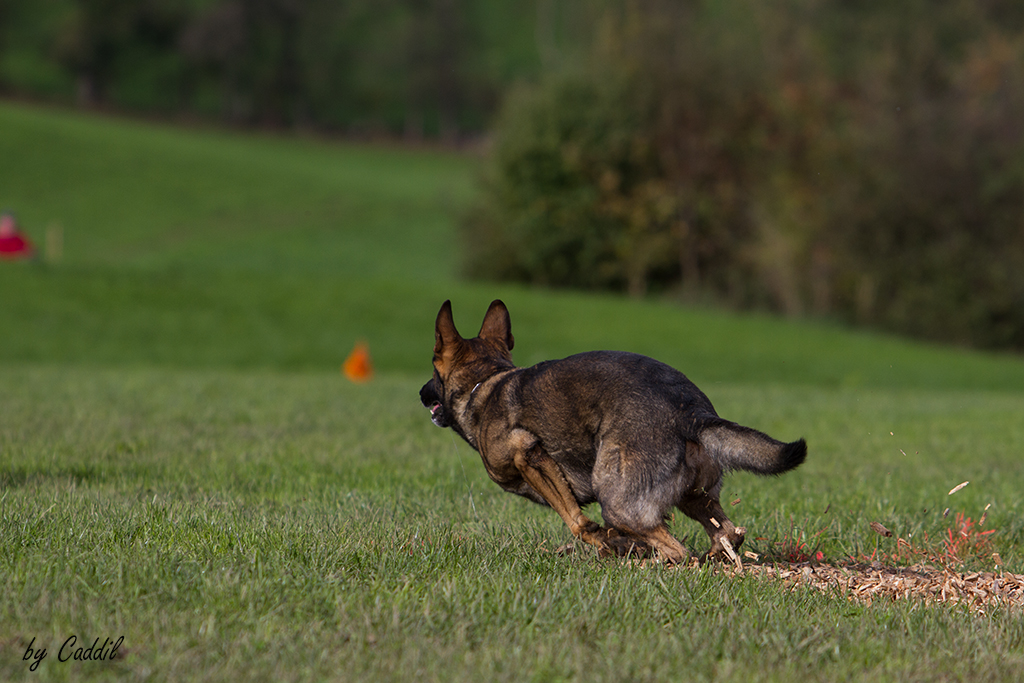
0, 100, 471, 280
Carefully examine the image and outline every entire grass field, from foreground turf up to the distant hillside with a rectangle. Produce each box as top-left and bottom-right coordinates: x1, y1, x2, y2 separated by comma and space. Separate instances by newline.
0, 98, 1024, 681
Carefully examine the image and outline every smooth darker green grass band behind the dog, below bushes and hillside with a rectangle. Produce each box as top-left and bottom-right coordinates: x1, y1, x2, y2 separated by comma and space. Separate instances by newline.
6, 266, 1024, 391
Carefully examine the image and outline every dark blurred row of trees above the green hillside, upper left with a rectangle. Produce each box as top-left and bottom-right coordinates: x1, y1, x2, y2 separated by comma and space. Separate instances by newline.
0, 0, 540, 139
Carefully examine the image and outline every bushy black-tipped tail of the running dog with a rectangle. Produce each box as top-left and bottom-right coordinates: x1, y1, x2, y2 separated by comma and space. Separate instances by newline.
700, 420, 807, 474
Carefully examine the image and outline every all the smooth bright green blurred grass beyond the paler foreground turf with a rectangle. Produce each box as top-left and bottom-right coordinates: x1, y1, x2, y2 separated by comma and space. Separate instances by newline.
6, 98, 1024, 391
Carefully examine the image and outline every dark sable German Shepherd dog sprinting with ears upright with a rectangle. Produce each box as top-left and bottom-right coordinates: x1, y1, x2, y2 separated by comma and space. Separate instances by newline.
420, 301, 807, 563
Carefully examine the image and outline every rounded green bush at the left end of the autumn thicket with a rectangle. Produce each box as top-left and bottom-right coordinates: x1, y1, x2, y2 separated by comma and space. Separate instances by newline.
468, 74, 675, 289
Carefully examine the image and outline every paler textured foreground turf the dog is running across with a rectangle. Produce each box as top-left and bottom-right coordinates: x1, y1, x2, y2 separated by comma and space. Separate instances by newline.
0, 368, 1024, 681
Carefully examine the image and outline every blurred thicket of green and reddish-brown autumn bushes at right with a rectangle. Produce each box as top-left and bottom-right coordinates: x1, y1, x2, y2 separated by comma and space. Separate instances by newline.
466, 0, 1024, 349
